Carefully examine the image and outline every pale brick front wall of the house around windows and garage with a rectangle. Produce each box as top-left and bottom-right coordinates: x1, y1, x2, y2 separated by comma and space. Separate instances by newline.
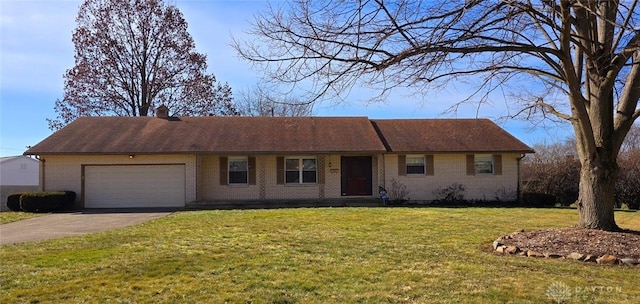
41, 154, 520, 203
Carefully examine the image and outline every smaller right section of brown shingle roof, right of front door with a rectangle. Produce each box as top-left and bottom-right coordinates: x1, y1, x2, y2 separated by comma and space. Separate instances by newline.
372, 119, 533, 153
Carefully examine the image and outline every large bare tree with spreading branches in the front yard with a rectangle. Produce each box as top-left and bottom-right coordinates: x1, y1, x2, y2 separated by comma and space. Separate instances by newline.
235, 0, 640, 230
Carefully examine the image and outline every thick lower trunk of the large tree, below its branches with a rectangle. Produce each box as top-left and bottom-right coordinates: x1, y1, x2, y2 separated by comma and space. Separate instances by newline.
578, 161, 620, 231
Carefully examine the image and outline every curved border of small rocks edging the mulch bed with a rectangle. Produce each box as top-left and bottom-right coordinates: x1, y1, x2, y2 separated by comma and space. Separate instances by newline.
492, 230, 640, 267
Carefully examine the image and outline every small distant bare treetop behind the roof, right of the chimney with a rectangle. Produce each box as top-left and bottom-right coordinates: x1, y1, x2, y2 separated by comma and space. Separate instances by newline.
235, 84, 313, 117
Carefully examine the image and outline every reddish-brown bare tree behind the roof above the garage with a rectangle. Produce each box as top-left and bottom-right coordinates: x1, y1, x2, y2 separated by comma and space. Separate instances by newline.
48, 0, 235, 130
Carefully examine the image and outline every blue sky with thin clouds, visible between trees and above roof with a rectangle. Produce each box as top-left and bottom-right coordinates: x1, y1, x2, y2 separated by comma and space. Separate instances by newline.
0, 0, 571, 156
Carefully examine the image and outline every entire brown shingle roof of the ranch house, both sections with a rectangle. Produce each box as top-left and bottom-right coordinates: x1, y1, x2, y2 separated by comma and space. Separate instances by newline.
25, 117, 533, 155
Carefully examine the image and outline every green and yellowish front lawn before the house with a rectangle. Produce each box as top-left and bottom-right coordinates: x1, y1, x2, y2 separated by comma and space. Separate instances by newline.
0, 208, 640, 303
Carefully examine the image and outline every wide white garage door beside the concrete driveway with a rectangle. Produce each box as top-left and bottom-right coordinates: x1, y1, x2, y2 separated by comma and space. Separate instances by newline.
84, 165, 185, 208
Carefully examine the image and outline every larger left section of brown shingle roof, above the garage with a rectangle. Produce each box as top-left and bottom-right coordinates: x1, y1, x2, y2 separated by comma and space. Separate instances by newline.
25, 117, 385, 154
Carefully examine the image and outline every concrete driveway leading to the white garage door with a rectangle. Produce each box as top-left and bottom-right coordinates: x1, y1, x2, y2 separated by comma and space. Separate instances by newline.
0, 209, 173, 245
